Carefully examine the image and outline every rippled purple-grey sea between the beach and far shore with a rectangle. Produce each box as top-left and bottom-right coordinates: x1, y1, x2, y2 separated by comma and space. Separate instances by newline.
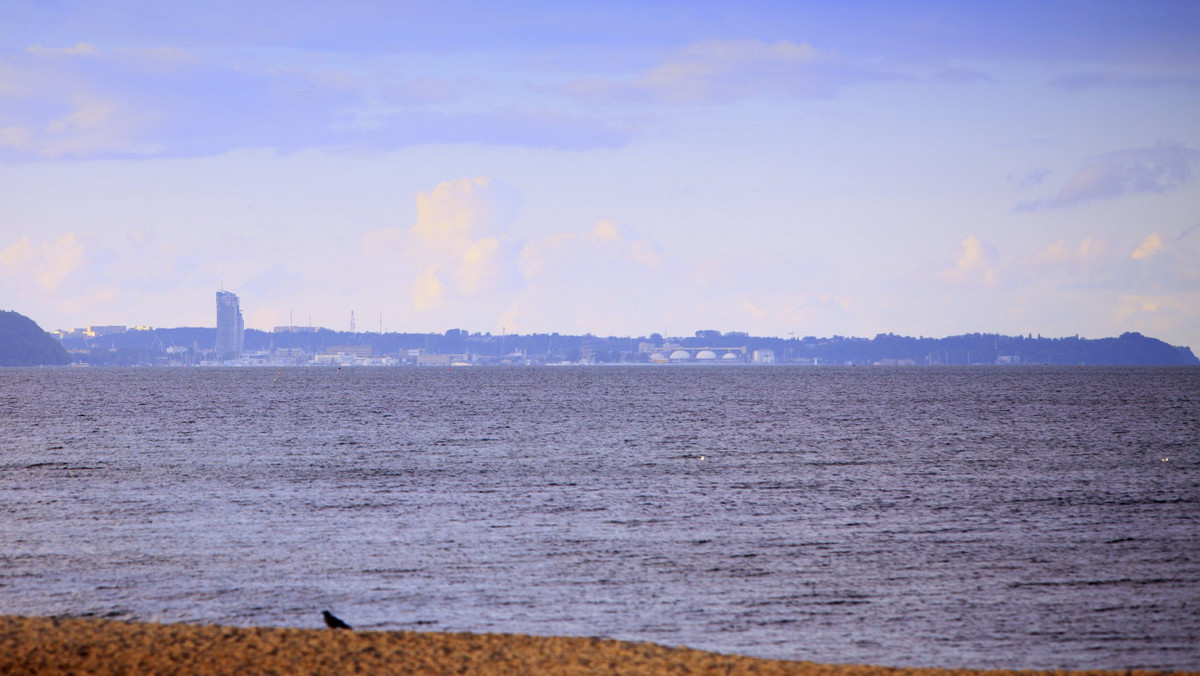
0, 365, 1200, 670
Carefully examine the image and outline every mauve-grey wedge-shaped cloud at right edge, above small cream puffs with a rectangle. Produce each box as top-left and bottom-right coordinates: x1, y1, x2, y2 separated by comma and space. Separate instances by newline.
1018, 143, 1200, 211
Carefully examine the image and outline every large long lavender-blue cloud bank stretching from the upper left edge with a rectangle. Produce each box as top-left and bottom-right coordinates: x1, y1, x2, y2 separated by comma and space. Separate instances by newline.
0, 43, 630, 160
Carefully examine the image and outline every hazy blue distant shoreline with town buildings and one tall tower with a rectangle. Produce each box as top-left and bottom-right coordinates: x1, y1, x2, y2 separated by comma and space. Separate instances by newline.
32, 291, 1200, 367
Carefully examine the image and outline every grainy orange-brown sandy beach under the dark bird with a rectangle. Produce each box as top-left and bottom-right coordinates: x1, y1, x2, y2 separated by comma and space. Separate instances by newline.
0, 616, 1180, 676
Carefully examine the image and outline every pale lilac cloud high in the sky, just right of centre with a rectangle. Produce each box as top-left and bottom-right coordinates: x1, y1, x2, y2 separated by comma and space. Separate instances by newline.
562, 40, 887, 104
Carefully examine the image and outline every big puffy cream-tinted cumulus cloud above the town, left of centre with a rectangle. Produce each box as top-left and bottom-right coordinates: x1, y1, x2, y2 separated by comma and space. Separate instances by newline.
360, 177, 670, 333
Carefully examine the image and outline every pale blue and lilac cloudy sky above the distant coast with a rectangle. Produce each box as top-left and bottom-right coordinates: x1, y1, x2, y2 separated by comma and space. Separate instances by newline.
0, 0, 1200, 348
